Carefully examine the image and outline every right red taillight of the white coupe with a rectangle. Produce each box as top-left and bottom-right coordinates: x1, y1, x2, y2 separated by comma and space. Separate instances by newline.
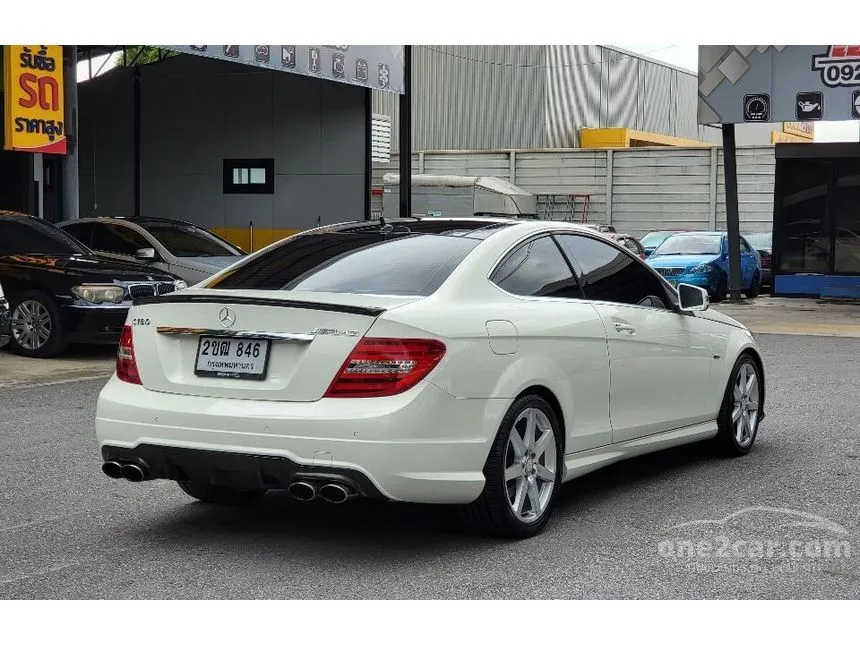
325, 338, 445, 398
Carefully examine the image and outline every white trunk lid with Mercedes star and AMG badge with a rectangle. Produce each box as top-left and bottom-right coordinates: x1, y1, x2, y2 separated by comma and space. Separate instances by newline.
128, 289, 420, 401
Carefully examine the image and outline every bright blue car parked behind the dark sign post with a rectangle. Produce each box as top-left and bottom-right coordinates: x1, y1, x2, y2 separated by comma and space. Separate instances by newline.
647, 232, 762, 302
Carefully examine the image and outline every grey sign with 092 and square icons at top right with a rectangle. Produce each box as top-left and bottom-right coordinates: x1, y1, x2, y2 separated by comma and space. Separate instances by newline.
698, 45, 860, 124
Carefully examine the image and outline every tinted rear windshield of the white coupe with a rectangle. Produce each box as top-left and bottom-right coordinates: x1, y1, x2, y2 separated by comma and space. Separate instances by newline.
207, 220, 504, 296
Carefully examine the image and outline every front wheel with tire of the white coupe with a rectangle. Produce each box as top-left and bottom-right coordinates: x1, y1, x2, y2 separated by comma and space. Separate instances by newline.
717, 354, 763, 457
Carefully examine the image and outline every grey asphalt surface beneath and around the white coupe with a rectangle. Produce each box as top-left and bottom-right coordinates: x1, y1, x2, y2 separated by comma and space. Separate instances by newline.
0, 335, 860, 598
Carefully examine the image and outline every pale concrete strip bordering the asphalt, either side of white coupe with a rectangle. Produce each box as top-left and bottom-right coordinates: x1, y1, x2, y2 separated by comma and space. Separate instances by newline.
0, 295, 860, 388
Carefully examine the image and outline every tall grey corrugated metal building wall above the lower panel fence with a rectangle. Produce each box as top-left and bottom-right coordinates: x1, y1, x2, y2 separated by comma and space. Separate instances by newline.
373, 45, 736, 151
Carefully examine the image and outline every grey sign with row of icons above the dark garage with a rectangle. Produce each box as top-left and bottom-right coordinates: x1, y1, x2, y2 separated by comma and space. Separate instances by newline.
172, 45, 404, 94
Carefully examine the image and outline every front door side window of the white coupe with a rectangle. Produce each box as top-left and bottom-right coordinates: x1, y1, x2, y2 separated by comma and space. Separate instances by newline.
556, 235, 670, 309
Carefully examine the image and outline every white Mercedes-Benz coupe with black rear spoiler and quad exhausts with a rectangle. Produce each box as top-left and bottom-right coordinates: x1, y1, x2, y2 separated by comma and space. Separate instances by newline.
96, 217, 765, 537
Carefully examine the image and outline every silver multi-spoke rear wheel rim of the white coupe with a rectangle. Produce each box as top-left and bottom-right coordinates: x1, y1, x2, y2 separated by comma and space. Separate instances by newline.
505, 408, 557, 524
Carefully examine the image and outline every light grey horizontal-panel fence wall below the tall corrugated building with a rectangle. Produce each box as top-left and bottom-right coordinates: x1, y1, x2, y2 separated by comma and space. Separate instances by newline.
373, 146, 774, 235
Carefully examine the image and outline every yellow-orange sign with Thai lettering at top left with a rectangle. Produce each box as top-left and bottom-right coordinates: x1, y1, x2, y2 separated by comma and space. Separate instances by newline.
3, 45, 66, 154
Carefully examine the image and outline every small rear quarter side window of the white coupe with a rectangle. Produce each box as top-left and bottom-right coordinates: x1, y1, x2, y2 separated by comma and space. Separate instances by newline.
490, 236, 582, 298
